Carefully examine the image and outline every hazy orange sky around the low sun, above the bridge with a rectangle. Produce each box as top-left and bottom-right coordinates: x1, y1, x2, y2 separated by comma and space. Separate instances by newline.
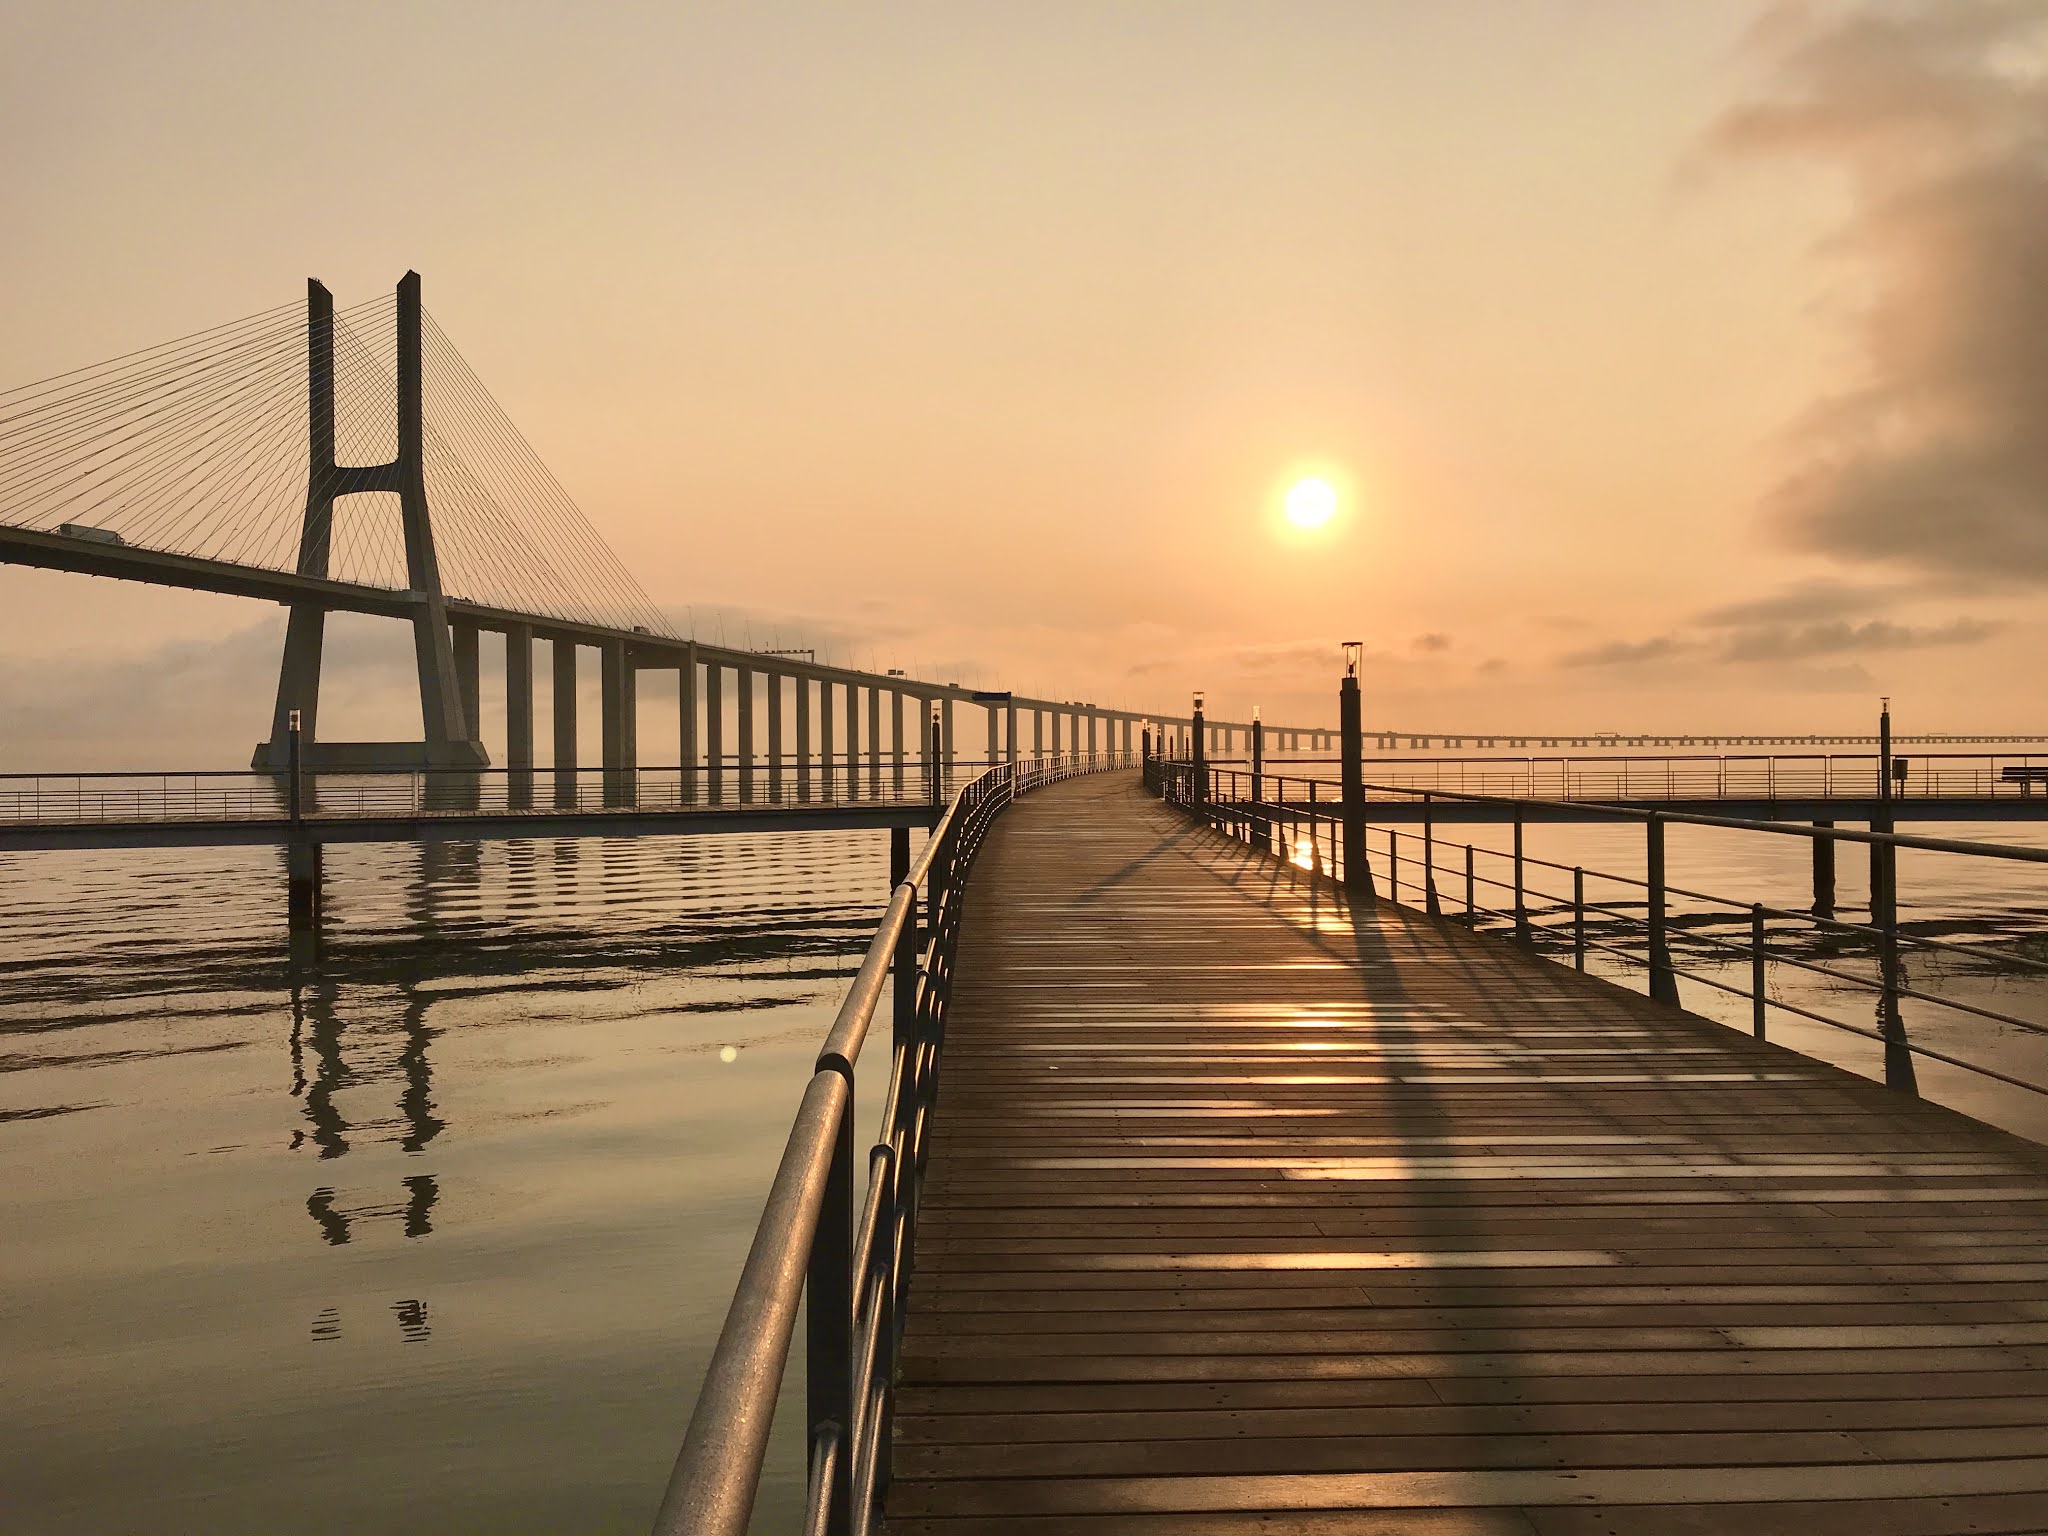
0, 0, 2048, 768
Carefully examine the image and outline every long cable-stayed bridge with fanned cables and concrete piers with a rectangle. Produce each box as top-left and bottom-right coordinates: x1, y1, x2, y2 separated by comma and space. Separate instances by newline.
0, 272, 1329, 803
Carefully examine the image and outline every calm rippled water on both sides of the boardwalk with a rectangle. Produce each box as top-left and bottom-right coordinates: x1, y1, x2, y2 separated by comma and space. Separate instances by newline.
0, 798, 2048, 1536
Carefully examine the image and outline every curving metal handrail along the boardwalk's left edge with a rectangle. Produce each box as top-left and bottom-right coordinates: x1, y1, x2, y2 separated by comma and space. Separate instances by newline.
653, 752, 1135, 1536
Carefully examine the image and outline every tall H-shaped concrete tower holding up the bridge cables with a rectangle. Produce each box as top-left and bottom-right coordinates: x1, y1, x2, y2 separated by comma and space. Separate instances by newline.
250, 272, 489, 770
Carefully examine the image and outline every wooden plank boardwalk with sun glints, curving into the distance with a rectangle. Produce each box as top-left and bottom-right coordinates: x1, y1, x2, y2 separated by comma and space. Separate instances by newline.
887, 774, 2048, 1536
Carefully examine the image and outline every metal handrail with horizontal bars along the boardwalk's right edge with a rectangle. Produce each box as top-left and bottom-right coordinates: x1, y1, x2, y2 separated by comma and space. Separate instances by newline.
1145, 760, 2048, 1096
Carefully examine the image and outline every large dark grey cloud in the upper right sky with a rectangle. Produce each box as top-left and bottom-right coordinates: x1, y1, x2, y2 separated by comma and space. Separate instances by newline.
1712, 0, 2048, 584
